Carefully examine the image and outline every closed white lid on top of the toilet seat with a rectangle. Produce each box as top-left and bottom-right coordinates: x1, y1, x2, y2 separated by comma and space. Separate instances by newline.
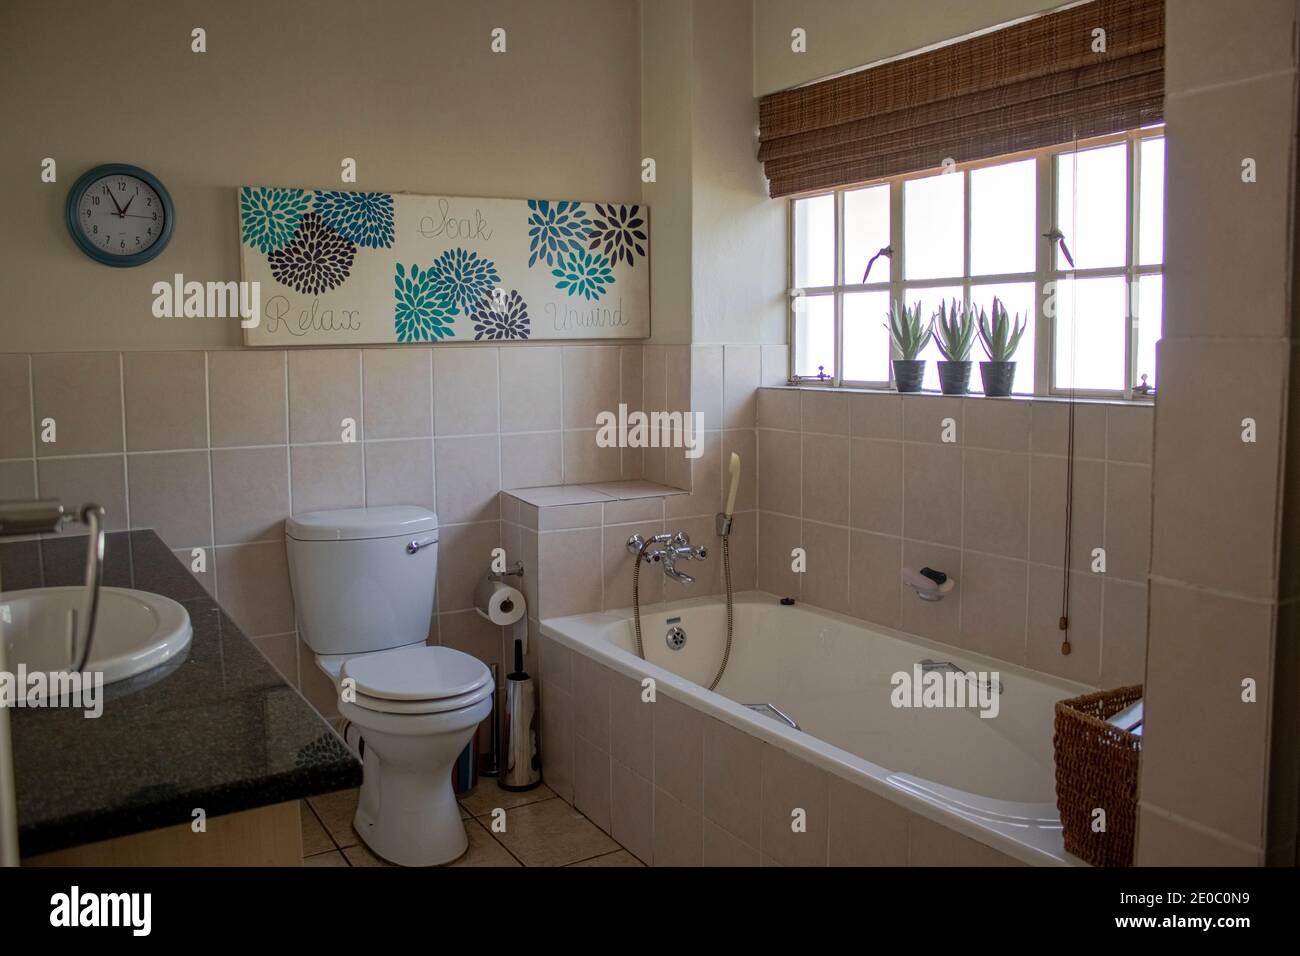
339, 644, 491, 701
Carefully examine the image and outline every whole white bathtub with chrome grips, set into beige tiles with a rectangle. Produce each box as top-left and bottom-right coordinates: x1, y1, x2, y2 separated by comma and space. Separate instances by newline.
541, 592, 1092, 865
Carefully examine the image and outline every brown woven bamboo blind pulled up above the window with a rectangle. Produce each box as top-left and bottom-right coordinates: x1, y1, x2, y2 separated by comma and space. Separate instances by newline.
758, 0, 1165, 196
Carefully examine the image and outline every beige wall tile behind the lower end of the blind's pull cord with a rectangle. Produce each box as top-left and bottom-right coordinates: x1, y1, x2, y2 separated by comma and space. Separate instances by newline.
1024, 564, 1097, 687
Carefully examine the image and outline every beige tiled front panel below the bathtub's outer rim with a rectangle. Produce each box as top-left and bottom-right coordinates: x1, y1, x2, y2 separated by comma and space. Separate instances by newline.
540, 637, 1019, 866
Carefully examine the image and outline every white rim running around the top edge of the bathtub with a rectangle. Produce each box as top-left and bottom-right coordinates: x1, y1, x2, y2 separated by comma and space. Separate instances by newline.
538, 591, 1096, 866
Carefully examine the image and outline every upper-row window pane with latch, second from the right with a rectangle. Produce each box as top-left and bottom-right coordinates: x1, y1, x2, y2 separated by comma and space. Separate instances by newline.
1057, 143, 1128, 269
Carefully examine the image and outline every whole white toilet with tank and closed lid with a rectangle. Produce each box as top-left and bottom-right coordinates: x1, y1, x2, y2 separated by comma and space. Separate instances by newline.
285, 506, 494, 866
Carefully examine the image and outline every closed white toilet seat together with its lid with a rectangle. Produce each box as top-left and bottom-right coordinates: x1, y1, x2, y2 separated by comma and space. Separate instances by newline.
339, 644, 494, 714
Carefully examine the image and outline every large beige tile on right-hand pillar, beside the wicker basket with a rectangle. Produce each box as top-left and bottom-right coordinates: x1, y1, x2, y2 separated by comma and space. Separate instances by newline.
1140, 580, 1274, 847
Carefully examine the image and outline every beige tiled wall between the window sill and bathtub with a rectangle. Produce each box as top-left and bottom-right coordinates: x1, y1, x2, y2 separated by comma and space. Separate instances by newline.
758, 388, 1153, 687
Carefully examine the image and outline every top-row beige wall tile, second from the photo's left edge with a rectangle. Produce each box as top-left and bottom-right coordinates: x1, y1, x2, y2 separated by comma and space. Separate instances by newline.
31, 352, 122, 458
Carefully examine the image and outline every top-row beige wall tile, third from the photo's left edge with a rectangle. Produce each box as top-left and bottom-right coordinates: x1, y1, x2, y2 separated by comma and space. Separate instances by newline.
122, 351, 208, 451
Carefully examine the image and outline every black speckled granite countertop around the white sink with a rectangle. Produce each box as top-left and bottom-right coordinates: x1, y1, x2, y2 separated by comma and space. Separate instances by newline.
0, 531, 361, 856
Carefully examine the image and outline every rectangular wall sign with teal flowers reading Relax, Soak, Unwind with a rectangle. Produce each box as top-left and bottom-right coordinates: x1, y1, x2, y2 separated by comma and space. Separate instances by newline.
239, 186, 650, 346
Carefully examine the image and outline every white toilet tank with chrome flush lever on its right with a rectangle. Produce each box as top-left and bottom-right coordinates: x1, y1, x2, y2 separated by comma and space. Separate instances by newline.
285, 505, 438, 654
